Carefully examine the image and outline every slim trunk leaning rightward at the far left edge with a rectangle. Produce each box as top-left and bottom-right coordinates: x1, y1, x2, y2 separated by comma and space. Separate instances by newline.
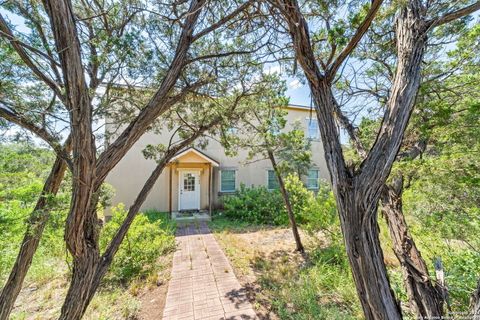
0, 156, 67, 320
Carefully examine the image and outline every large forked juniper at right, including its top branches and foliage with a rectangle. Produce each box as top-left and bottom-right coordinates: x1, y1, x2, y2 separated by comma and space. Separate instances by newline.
269, 0, 480, 319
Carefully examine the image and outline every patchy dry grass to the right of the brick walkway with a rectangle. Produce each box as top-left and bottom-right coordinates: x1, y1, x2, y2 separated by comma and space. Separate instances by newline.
211, 221, 358, 319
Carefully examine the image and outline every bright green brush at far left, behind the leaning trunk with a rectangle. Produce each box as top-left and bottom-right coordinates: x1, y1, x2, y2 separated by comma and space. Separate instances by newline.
0, 144, 70, 283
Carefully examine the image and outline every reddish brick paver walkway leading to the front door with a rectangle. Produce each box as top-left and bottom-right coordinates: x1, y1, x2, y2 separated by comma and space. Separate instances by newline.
163, 223, 258, 320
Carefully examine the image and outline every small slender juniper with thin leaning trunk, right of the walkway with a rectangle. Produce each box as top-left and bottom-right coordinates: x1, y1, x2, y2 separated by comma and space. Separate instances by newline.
222, 75, 311, 253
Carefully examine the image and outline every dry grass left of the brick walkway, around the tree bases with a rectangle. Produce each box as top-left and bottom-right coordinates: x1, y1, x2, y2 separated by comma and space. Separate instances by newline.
11, 253, 173, 320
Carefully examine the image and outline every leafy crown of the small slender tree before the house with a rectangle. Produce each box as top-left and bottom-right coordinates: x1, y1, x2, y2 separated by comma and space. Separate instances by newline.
221, 75, 311, 175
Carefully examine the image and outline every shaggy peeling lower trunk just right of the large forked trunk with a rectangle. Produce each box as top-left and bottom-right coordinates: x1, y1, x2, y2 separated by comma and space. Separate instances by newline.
382, 177, 444, 319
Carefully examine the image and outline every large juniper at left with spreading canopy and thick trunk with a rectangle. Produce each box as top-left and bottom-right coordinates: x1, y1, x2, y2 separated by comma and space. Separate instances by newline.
0, 0, 274, 319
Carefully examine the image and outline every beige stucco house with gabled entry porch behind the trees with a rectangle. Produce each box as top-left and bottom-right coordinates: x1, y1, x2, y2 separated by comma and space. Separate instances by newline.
106, 105, 328, 218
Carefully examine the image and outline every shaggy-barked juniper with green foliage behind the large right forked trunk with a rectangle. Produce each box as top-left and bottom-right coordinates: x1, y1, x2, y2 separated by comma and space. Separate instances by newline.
337, 13, 476, 318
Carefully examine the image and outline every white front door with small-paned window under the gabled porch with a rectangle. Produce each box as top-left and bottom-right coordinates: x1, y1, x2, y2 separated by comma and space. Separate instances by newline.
178, 171, 200, 210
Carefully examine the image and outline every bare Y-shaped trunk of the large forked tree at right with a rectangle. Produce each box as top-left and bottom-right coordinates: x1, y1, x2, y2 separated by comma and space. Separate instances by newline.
276, 0, 427, 319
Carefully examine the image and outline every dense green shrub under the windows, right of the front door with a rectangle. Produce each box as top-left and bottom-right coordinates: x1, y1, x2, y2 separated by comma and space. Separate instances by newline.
223, 184, 288, 225
